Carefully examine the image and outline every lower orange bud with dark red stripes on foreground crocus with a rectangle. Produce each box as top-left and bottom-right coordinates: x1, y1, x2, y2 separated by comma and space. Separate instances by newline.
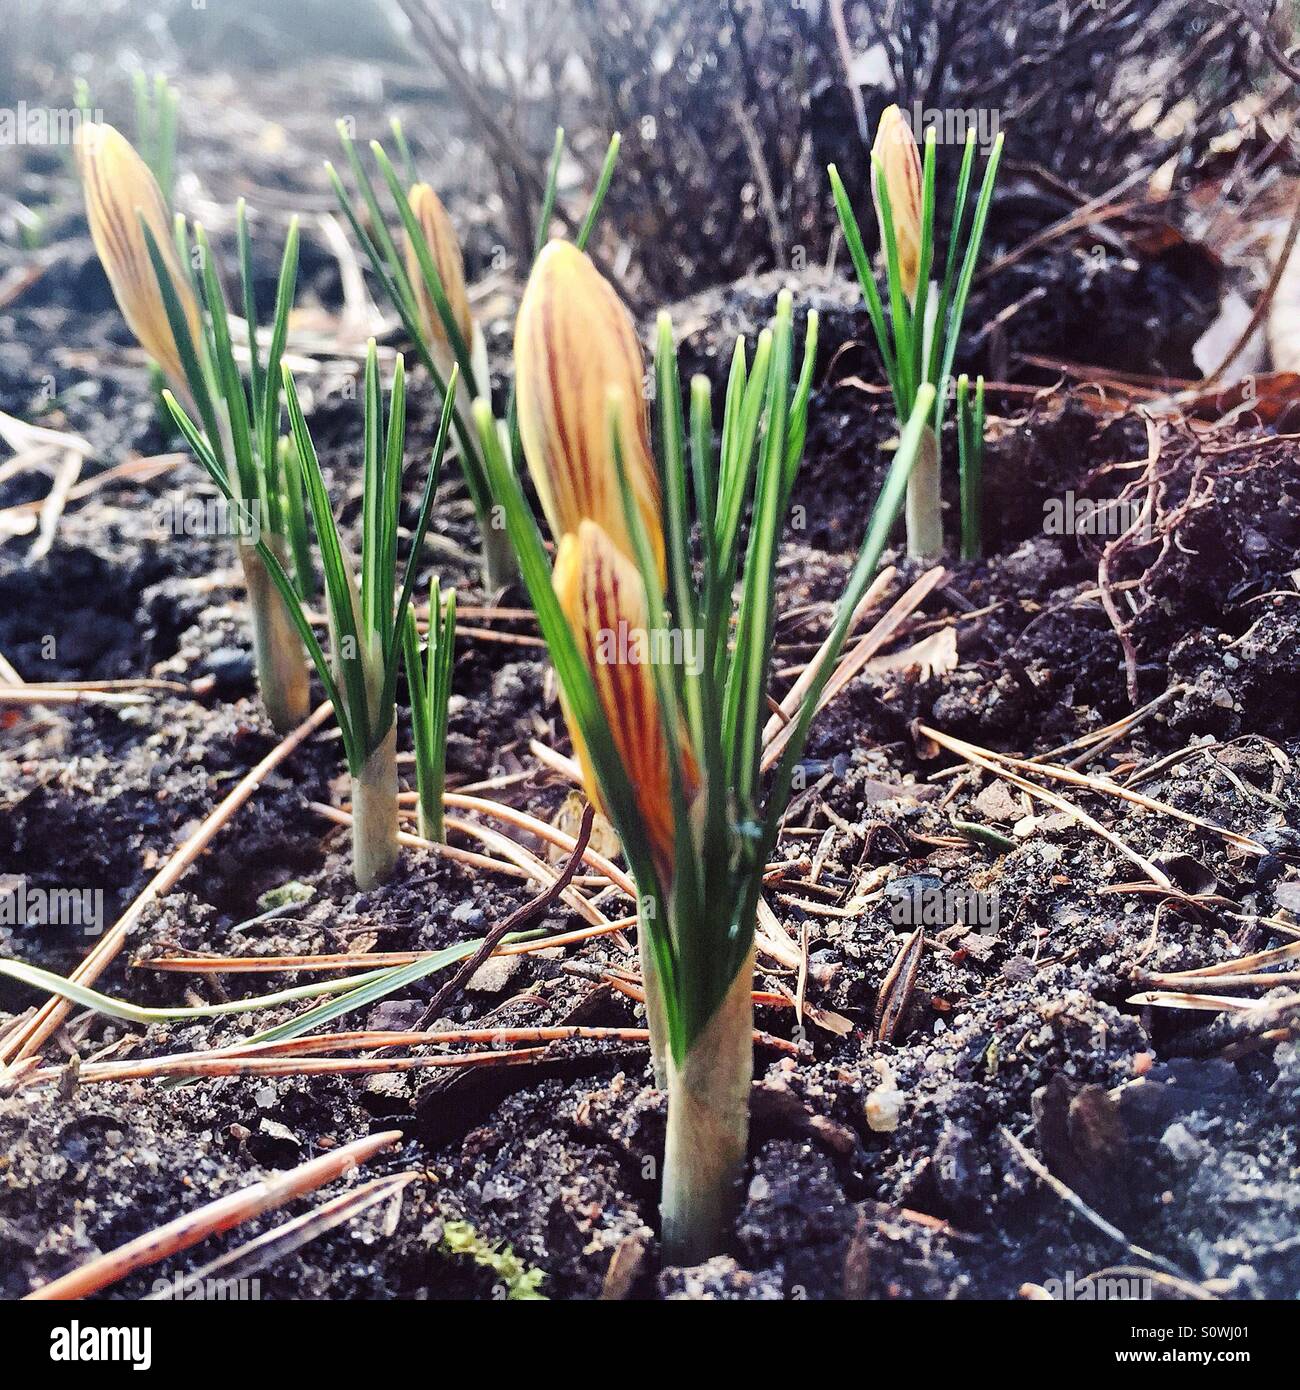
552, 518, 699, 884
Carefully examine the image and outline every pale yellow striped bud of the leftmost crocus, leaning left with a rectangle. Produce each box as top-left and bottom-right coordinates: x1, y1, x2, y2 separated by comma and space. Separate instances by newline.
76, 122, 200, 395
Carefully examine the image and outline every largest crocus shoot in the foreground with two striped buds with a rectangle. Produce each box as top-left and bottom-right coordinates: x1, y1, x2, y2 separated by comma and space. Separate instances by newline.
474, 242, 933, 1262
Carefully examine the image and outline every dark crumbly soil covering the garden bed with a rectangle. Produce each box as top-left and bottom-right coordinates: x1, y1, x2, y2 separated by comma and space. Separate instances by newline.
0, 65, 1300, 1300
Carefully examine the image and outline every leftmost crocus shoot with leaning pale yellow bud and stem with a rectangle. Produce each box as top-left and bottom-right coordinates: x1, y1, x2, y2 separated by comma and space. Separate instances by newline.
78, 124, 313, 733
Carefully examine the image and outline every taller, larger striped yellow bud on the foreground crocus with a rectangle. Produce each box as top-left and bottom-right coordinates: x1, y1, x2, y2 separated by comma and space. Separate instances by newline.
514, 240, 663, 574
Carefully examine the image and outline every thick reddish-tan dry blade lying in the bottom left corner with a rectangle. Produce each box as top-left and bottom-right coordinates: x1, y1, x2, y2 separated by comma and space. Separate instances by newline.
26, 1130, 402, 1301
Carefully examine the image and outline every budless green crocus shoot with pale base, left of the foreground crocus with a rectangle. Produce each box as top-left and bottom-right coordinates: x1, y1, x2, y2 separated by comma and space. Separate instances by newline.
164, 341, 456, 890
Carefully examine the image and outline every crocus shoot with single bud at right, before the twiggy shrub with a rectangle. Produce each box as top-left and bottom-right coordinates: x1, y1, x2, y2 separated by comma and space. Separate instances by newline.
829, 106, 1002, 559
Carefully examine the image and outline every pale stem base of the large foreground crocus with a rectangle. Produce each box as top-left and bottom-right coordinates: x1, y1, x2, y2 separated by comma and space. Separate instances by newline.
660, 948, 754, 1265
